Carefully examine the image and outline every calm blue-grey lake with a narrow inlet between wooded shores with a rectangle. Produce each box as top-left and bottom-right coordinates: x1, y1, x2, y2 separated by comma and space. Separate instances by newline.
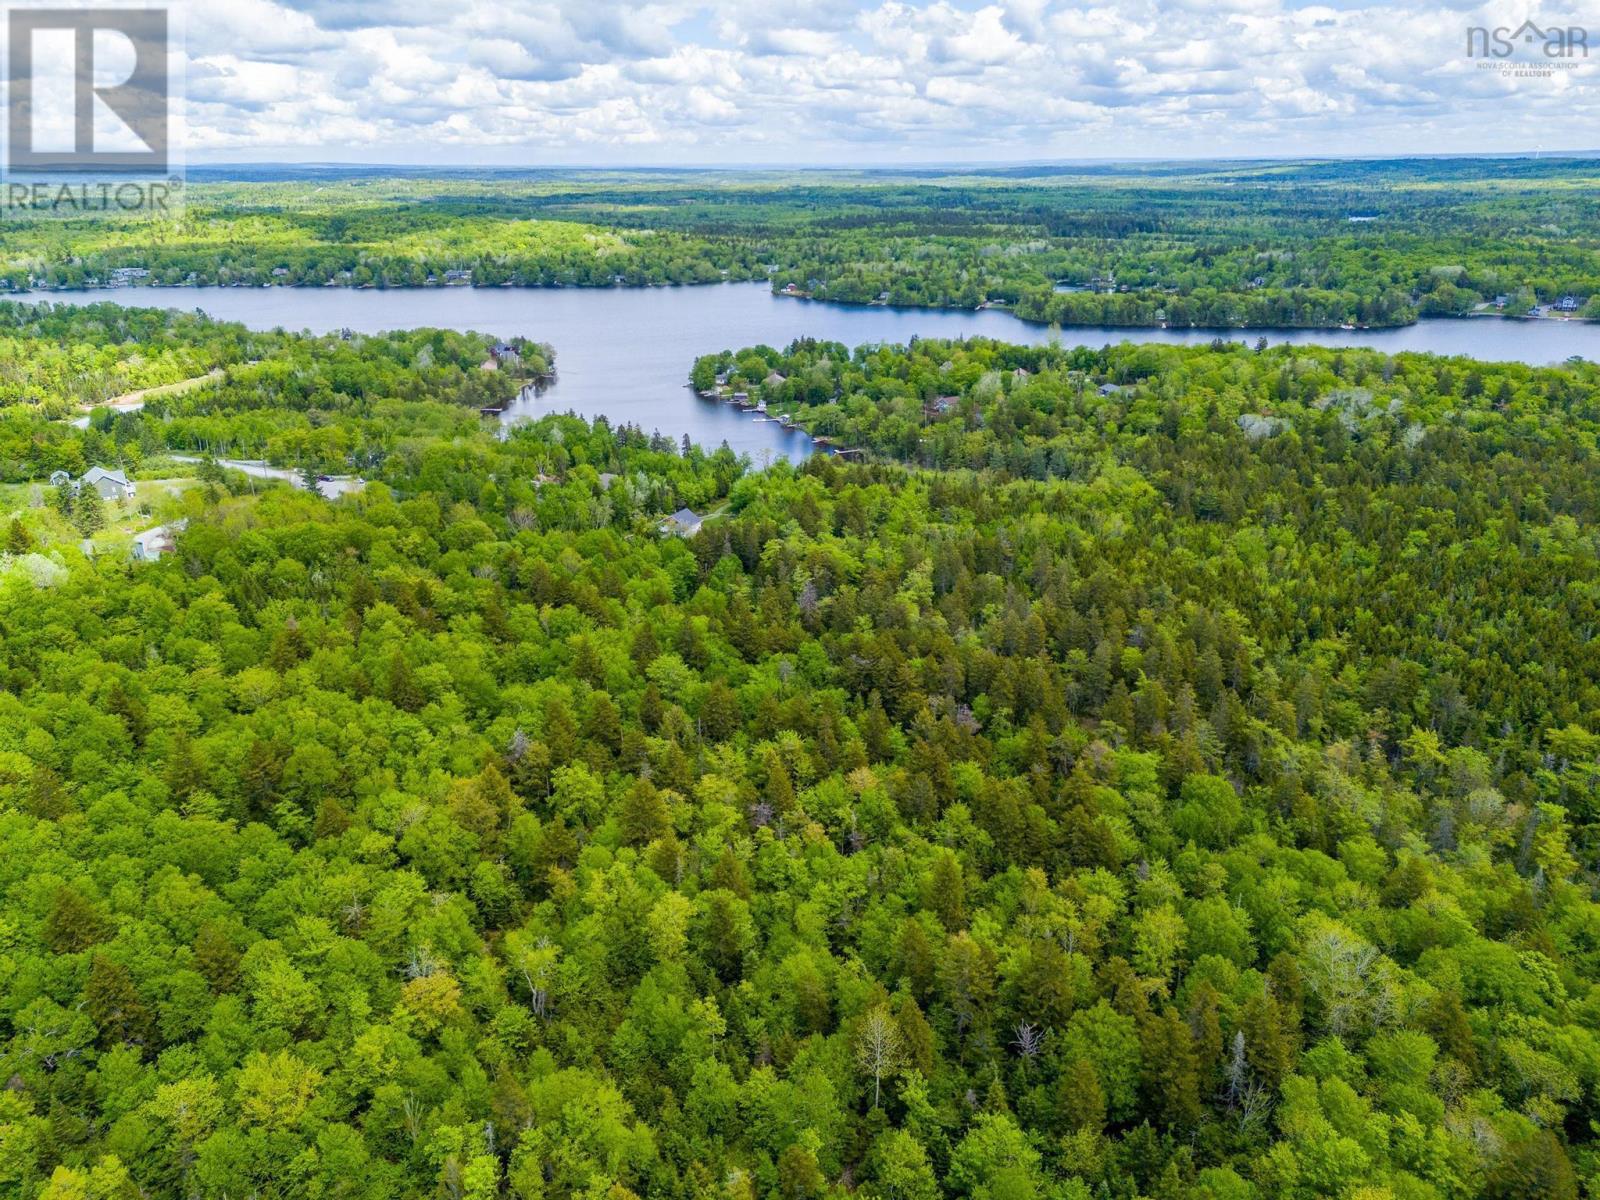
37, 283, 1600, 464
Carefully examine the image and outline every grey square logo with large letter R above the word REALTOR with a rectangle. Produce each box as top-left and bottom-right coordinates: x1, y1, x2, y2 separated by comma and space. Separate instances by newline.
6, 8, 170, 174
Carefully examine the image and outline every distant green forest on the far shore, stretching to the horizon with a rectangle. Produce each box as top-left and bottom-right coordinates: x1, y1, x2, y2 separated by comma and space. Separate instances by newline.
9, 158, 1600, 328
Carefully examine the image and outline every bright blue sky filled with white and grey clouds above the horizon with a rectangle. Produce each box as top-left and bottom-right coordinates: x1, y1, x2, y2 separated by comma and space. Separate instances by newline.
90, 0, 1600, 166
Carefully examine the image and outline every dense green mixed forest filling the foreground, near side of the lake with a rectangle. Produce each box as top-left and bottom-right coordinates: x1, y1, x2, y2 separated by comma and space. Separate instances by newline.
0, 306, 1600, 1200
